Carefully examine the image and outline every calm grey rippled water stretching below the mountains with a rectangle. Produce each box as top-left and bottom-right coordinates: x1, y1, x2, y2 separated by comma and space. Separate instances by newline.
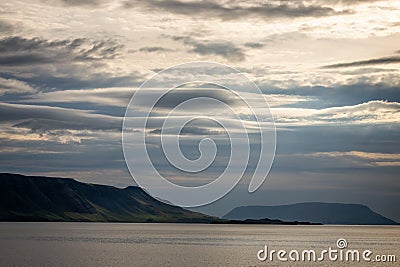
0, 223, 400, 266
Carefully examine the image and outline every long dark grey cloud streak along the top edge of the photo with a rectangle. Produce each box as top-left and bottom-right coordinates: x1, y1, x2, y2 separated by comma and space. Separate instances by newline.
124, 0, 349, 20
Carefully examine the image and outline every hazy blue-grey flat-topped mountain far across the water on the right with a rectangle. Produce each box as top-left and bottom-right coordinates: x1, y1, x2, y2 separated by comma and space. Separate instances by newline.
222, 202, 397, 225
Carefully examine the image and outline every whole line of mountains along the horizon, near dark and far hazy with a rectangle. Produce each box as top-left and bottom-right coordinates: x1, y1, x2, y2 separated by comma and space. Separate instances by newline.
0, 173, 398, 225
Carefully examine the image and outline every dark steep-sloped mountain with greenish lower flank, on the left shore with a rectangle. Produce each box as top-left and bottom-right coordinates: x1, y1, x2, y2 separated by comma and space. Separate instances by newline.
0, 173, 216, 223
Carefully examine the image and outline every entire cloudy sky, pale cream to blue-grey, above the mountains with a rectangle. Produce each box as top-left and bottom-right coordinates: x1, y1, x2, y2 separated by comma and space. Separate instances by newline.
0, 0, 400, 221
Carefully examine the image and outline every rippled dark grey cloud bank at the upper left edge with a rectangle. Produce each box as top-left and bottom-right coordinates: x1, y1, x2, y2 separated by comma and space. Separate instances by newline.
0, 36, 143, 91
